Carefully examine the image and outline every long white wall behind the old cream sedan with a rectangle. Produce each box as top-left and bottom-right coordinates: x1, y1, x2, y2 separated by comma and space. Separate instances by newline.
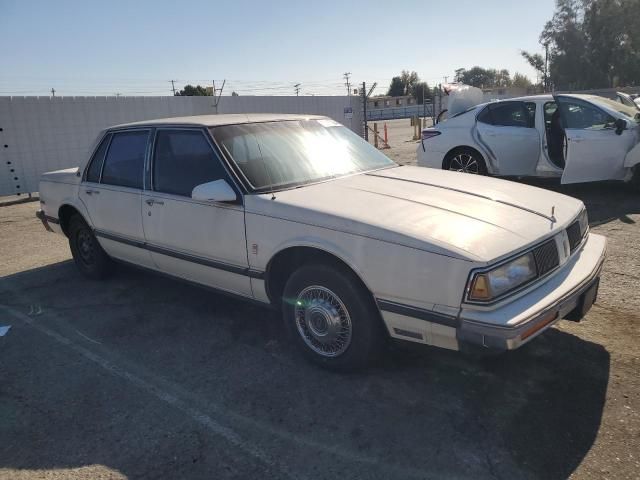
0, 96, 362, 195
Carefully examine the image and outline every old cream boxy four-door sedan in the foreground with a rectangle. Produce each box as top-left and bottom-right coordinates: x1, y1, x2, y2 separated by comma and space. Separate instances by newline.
38, 115, 605, 369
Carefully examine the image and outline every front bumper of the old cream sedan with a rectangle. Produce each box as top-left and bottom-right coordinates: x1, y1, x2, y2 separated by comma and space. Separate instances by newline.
456, 234, 607, 350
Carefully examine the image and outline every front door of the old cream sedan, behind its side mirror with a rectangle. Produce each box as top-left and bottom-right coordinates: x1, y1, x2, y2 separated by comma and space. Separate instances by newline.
142, 128, 251, 296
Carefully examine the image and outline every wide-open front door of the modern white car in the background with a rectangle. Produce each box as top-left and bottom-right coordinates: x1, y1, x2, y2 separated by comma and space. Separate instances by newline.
554, 95, 633, 183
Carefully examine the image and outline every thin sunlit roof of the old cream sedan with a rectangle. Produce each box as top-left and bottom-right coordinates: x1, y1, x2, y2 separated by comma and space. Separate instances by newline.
111, 113, 326, 128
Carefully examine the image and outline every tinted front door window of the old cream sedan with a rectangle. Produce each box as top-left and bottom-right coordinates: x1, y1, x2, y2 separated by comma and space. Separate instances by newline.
153, 130, 227, 197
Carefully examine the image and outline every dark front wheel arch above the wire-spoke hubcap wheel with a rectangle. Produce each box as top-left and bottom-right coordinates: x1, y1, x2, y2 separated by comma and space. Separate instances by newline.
264, 244, 379, 310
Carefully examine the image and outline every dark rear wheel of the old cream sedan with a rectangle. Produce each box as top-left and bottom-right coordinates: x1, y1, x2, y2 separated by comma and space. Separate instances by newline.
69, 215, 113, 280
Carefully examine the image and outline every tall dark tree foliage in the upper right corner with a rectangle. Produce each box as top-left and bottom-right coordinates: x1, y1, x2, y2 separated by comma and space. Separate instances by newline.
540, 0, 640, 90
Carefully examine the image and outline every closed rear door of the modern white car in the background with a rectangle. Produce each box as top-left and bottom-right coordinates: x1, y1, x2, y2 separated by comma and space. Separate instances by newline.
476, 101, 540, 175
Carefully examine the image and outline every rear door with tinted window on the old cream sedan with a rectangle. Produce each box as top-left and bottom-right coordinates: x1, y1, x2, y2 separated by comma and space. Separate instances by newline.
79, 129, 153, 268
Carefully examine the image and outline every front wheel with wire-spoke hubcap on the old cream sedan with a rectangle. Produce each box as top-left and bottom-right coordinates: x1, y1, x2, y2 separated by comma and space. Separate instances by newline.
282, 264, 385, 370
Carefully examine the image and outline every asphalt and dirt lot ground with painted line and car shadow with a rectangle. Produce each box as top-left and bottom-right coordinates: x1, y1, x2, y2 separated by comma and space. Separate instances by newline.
0, 124, 640, 479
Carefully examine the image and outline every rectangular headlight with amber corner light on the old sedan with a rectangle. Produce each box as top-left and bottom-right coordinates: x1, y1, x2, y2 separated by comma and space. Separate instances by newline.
469, 252, 537, 302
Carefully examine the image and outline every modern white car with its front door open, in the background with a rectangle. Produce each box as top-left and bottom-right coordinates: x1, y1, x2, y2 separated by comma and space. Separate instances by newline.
417, 94, 640, 183
